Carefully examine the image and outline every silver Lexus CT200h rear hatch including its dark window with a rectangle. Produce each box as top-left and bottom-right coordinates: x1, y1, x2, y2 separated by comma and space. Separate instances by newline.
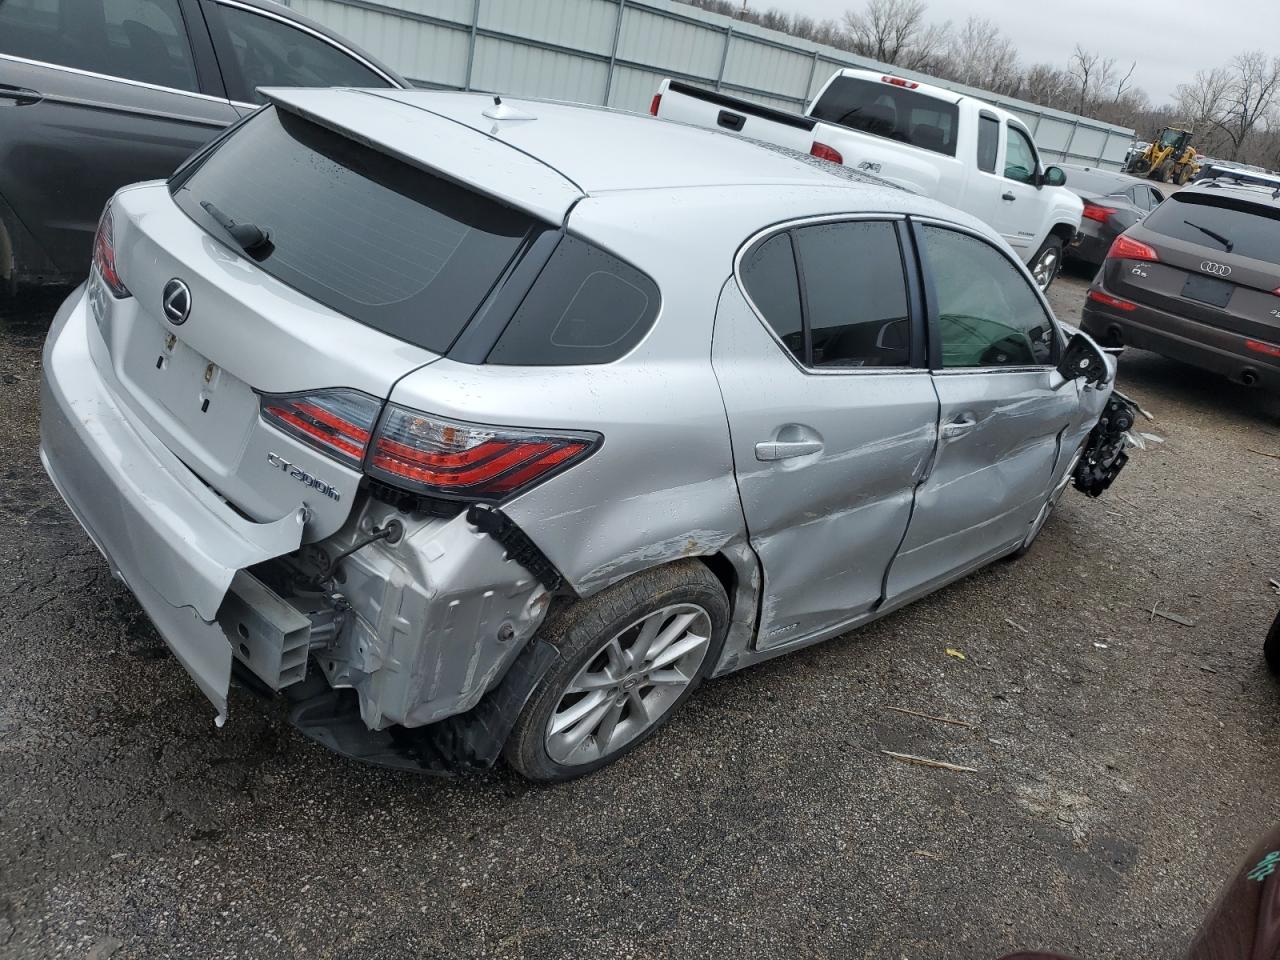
99, 101, 576, 539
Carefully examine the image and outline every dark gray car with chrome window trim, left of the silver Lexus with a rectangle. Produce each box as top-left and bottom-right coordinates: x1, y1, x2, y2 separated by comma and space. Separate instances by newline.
0, 0, 408, 293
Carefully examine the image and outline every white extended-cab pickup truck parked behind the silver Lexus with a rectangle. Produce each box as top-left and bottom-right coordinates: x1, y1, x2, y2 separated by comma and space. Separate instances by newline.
650, 69, 1084, 289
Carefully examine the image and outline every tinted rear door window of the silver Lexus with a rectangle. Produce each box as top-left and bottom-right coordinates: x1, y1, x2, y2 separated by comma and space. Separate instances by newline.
741, 220, 911, 369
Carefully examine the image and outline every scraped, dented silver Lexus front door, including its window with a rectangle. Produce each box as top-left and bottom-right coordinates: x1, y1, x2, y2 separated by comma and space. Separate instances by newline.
887, 223, 1079, 600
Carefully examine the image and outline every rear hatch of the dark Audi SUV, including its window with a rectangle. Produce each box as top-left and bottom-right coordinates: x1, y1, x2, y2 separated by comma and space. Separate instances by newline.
1106, 189, 1280, 344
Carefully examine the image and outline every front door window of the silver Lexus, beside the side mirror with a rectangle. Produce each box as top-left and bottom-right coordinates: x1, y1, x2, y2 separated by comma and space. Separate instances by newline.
922, 227, 1055, 370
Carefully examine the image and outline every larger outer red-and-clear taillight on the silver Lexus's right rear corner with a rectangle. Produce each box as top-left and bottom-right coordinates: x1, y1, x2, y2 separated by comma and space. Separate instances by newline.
365, 404, 600, 499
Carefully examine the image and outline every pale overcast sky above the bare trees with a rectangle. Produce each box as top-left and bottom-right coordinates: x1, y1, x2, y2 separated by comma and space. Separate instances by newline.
768, 0, 1259, 105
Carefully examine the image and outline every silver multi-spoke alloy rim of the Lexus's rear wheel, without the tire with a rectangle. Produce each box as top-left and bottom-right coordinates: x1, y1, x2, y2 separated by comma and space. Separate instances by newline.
545, 603, 712, 765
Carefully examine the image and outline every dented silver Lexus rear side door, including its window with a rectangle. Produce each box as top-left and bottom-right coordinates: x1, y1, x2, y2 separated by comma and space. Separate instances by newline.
712, 219, 938, 649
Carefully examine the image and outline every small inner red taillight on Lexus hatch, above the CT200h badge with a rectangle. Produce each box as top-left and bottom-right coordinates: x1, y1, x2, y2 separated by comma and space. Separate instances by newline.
259, 390, 383, 470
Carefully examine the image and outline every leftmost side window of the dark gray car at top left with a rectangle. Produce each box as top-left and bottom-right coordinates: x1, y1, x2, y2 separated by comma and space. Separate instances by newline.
0, 0, 198, 91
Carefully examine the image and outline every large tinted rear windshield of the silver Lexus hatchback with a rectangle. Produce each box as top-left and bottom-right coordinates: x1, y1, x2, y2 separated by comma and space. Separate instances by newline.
174, 108, 534, 353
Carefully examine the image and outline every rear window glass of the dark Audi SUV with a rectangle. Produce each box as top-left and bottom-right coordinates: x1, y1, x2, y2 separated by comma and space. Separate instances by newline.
1142, 192, 1280, 264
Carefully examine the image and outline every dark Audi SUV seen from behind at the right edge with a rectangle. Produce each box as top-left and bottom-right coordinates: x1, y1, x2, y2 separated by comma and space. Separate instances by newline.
1082, 177, 1280, 390
